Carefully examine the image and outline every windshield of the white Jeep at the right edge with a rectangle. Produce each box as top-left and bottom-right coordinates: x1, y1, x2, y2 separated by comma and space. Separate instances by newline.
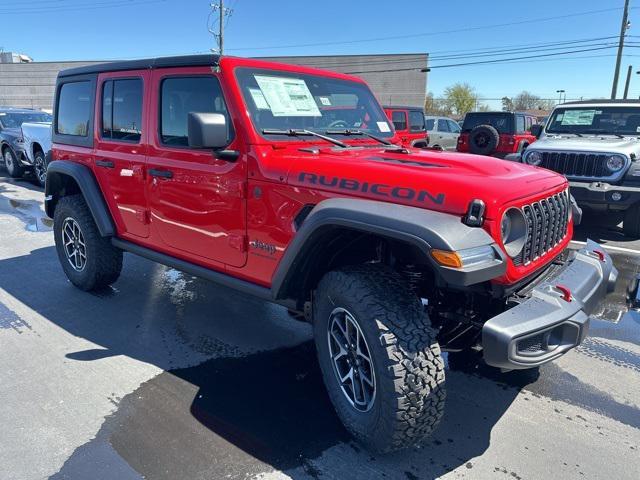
546, 106, 640, 136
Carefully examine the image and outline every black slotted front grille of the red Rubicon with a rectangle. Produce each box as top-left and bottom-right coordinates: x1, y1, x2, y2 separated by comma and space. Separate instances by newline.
513, 190, 571, 266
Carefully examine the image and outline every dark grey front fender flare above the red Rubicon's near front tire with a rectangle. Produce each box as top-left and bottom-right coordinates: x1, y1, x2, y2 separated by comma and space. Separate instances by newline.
272, 198, 506, 299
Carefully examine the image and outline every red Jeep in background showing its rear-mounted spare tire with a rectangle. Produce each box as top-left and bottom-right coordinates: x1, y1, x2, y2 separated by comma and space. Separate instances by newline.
457, 112, 538, 158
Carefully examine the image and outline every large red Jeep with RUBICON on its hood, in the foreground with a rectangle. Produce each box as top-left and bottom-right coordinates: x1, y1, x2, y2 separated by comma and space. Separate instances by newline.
45, 55, 617, 451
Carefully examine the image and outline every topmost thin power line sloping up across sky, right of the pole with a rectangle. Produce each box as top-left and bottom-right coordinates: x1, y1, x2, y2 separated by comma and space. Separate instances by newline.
224, 7, 637, 51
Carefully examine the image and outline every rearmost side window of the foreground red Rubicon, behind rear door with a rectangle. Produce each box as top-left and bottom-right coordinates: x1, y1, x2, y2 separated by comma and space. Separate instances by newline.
56, 81, 93, 137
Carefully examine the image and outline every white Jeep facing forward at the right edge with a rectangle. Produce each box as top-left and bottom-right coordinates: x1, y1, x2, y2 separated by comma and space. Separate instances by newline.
524, 100, 640, 238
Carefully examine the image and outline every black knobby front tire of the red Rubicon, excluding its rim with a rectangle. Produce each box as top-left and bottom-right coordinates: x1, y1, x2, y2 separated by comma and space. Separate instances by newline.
313, 265, 445, 452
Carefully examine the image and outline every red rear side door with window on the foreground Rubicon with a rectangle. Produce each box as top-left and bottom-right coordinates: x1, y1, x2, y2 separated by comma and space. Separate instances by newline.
94, 70, 149, 238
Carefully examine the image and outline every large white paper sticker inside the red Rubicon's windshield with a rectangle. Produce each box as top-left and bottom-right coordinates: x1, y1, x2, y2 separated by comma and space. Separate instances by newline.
254, 75, 322, 117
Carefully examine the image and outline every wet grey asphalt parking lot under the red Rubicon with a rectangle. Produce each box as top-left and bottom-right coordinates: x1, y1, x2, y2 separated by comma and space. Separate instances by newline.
0, 171, 640, 480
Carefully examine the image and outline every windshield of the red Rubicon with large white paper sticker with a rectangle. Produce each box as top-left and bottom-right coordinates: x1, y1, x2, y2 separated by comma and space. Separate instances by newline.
237, 68, 393, 139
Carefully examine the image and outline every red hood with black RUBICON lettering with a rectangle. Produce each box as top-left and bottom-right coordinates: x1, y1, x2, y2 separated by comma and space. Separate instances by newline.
284, 148, 566, 218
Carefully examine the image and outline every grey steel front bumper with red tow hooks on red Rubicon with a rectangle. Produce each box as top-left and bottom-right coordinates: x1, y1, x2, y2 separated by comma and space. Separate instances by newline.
482, 240, 618, 370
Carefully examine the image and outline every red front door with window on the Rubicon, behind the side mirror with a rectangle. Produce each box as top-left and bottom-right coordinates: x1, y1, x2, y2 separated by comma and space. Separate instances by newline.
147, 68, 247, 267
